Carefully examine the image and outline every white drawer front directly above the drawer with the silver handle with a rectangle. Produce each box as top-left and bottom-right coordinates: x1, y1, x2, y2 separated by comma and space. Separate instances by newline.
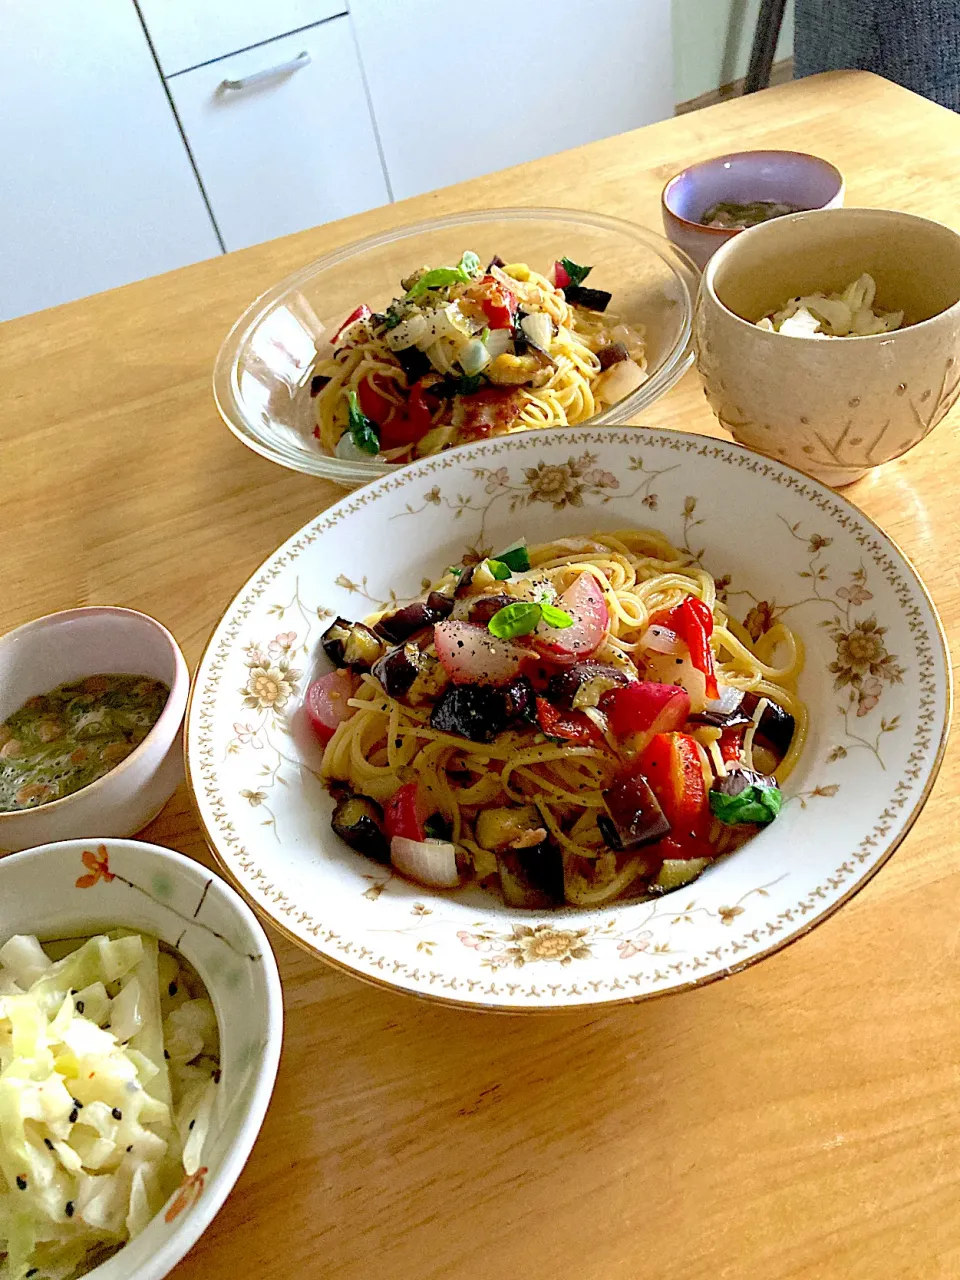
140, 0, 347, 76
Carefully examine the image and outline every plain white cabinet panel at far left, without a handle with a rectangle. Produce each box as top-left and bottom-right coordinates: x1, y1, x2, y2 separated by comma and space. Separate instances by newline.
0, 0, 220, 319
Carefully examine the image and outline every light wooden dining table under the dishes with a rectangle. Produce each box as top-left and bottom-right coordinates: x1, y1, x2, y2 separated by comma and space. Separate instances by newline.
0, 73, 960, 1280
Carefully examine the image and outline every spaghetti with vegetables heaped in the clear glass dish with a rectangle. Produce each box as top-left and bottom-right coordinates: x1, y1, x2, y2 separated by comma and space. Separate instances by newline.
311, 251, 646, 462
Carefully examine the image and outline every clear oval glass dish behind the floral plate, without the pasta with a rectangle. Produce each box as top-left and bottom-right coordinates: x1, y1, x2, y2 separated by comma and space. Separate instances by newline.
214, 209, 699, 488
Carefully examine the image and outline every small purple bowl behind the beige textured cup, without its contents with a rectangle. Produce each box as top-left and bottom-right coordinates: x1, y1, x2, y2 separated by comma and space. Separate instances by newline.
660, 151, 844, 270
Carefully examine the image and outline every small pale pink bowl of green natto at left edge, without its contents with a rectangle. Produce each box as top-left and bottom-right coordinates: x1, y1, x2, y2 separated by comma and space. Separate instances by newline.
0, 605, 189, 852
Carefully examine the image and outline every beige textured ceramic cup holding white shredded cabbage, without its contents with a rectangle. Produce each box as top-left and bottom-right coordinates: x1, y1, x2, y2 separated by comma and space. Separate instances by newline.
695, 209, 960, 488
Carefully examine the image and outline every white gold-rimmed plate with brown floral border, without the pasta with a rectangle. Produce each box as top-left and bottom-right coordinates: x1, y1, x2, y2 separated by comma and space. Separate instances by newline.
187, 428, 951, 1010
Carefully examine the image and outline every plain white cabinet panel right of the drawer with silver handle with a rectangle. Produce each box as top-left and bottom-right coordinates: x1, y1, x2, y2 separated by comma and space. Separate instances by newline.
351, 0, 673, 204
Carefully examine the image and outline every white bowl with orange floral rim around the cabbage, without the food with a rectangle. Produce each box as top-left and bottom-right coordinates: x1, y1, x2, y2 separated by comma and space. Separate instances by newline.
0, 838, 283, 1280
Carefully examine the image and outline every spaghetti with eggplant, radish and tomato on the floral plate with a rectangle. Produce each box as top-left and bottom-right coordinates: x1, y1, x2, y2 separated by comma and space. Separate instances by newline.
306, 530, 808, 910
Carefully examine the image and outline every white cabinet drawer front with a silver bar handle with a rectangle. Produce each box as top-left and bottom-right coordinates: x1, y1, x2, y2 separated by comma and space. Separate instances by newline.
168, 18, 389, 250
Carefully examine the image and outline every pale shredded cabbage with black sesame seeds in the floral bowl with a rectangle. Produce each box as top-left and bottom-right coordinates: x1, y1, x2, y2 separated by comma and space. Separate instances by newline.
0, 931, 220, 1280
